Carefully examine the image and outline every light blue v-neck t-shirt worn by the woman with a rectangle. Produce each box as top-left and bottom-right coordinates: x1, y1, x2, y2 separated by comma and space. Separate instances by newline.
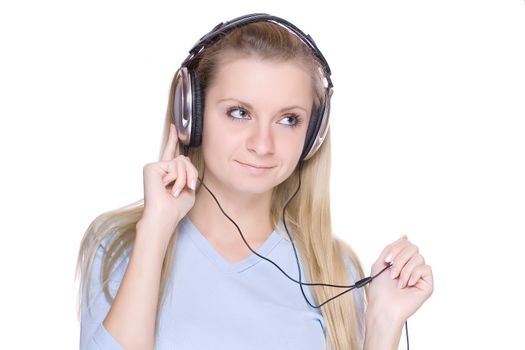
80, 217, 364, 350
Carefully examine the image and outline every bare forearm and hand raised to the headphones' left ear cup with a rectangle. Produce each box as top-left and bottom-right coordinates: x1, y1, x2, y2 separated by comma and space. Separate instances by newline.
103, 124, 198, 350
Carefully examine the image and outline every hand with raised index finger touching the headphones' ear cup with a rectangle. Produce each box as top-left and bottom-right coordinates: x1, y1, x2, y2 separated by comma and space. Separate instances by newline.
137, 123, 198, 243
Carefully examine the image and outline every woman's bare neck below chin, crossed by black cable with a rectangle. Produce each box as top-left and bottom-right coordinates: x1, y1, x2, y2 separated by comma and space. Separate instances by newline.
188, 175, 274, 245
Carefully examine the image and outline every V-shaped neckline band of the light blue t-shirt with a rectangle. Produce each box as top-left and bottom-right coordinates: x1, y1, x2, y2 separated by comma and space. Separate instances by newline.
180, 216, 283, 273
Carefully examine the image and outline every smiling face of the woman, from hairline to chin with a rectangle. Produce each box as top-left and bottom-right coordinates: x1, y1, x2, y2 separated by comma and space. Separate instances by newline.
202, 56, 313, 194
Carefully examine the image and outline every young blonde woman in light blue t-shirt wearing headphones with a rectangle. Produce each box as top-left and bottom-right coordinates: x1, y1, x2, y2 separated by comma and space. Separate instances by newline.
78, 14, 433, 350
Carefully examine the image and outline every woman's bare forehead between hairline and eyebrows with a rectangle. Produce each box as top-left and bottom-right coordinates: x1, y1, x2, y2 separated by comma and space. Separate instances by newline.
206, 56, 313, 108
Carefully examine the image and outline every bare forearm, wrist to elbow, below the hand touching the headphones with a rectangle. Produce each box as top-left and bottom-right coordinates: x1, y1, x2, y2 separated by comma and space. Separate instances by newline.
103, 221, 167, 349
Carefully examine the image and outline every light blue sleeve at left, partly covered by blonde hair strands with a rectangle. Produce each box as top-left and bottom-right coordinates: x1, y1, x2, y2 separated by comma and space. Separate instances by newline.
80, 244, 129, 350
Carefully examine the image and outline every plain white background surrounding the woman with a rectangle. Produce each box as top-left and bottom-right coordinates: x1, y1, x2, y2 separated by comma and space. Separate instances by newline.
0, 0, 525, 349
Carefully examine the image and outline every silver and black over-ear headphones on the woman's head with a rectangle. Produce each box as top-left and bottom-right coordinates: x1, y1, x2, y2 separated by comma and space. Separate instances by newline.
172, 13, 333, 161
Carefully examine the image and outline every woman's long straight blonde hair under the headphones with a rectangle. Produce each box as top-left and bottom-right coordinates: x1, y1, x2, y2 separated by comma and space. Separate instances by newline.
77, 22, 364, 350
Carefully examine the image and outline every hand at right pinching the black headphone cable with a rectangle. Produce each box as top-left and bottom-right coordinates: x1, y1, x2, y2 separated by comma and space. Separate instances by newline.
367, 236, 434, 324
